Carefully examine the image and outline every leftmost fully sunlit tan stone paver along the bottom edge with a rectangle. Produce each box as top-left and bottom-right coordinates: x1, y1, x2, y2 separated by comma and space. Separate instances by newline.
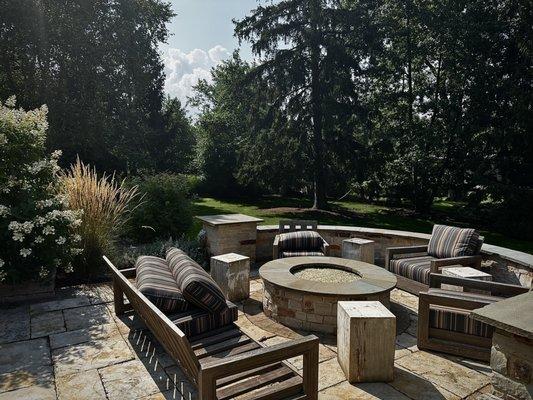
56, 369, 107, 400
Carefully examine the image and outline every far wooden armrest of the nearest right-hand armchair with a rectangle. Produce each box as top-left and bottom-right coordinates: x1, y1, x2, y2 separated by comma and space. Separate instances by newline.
429, 273, 528, 297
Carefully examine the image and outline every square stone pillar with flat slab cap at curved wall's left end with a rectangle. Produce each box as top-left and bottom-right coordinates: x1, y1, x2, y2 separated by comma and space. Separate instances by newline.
196, 214, 263, 262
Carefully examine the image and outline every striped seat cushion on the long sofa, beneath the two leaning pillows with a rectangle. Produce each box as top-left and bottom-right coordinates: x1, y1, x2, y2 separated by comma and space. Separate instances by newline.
169, 302, 238, 337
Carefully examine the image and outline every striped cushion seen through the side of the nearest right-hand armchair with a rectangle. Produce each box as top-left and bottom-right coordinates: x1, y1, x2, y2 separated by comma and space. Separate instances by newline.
429, 306, 494, 338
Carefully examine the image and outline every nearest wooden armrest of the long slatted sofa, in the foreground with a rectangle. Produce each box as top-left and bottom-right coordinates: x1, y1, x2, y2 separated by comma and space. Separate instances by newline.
198, 335, 319, 400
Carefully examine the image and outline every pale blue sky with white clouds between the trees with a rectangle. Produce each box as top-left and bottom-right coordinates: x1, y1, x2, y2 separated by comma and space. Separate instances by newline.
160, 0, 258, 113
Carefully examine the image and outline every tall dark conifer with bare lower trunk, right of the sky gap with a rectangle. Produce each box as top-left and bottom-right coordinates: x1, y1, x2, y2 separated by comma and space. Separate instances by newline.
235, 0, 376, 208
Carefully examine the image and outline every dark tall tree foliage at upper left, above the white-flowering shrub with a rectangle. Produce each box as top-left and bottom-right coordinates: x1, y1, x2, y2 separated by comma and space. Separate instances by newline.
0, 0, 176, 171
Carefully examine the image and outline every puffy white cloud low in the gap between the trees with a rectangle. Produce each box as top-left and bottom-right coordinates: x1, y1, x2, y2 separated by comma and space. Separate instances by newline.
163, 45, 231, 111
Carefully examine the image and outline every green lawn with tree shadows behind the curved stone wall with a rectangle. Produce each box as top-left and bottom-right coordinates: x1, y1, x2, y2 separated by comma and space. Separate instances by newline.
190, 197, 533, 253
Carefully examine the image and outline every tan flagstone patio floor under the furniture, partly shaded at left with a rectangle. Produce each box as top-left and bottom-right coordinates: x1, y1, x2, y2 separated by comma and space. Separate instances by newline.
0, 278, 492, 400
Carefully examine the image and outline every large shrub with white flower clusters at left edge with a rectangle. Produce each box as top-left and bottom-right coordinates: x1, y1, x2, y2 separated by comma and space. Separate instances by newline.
0, 97, 81, 283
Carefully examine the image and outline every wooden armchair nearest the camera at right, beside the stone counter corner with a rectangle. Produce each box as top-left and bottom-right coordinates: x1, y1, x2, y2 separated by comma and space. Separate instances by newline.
418, 273, 528, 361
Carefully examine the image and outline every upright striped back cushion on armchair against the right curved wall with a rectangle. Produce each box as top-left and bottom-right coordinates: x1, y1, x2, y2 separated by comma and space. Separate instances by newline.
428, 225, 479, 258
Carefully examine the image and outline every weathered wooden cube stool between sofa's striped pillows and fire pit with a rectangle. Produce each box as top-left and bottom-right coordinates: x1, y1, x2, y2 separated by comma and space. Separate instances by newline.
211, 253, 250, 301
